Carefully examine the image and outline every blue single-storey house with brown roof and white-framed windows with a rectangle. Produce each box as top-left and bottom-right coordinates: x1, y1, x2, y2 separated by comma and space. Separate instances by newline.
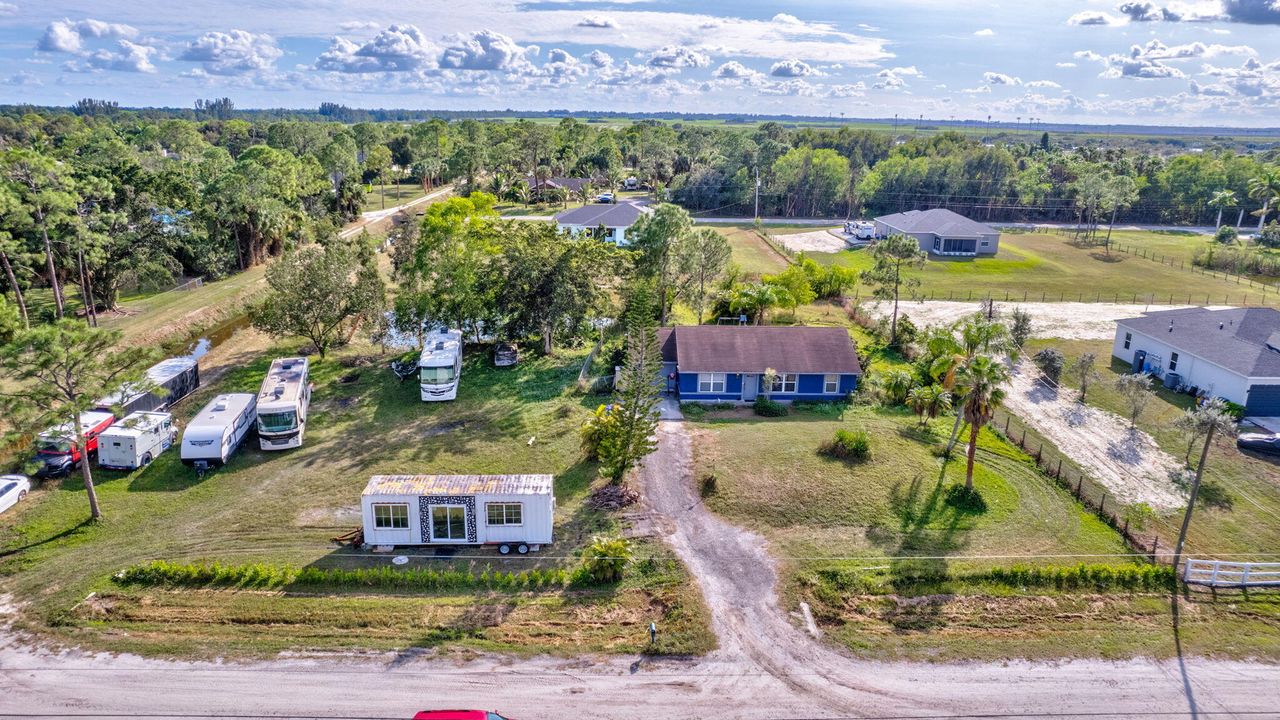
658, 325, 863, 402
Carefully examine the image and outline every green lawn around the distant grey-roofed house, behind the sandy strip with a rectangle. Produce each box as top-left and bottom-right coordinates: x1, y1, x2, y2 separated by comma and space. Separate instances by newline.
808, 233, 1280, 305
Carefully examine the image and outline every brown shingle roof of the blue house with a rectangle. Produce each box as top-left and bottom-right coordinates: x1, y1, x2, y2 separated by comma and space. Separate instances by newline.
658, 325, 863, 374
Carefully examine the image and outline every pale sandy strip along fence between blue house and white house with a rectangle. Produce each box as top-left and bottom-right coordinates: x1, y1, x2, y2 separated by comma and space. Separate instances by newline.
1005, 361, 1187, 511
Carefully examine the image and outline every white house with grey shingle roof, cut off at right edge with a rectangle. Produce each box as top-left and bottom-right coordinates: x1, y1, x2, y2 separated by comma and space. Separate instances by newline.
1111, 307, 1280, 416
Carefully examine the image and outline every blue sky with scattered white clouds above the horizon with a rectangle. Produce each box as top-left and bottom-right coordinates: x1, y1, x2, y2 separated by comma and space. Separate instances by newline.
0, 0, 1280, 126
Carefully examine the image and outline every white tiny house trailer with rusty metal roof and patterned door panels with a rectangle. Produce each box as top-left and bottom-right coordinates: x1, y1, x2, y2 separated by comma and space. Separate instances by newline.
360, 475, 556, 555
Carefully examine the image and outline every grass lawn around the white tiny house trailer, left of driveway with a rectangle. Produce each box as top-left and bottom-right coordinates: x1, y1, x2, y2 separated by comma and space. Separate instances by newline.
0, 341, 714, 655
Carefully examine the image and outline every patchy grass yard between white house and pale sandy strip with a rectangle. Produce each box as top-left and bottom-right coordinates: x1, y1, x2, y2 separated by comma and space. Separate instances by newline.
1027, 340, 1280, 561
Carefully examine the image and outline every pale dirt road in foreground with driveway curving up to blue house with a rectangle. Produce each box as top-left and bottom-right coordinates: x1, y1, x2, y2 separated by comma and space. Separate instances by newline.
0, 409, 1280, 720
